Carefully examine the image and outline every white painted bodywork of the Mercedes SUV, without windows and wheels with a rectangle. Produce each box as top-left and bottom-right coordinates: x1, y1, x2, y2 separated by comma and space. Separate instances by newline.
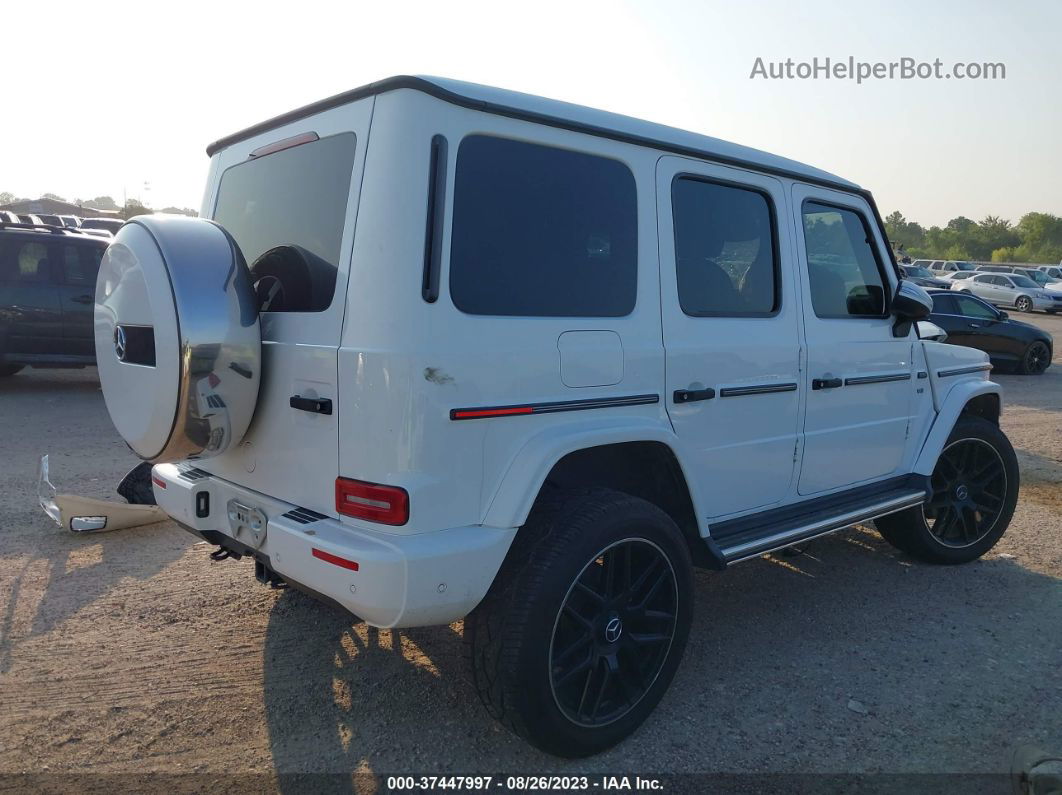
143, 82, 998, 626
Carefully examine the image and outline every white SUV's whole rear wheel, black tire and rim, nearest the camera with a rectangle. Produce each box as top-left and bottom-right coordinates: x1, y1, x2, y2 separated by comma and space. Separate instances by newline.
464, 488, 692, 758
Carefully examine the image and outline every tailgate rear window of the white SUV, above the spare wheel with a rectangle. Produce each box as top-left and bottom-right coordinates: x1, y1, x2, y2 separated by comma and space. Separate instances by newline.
213, 133, 355, 312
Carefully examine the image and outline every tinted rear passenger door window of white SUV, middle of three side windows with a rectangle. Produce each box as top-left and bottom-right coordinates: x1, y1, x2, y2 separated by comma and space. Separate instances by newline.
671, 177, 778, 316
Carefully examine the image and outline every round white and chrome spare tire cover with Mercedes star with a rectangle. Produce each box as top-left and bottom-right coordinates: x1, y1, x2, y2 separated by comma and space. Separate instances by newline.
95, 215, 261, 463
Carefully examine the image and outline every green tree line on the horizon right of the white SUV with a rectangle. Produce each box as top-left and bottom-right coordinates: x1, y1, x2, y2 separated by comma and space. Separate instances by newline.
885, 210, 1062, 264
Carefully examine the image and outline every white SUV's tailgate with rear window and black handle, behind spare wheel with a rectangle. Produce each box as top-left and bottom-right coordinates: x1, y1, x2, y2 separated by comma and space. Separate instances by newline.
200, 99, 373, 516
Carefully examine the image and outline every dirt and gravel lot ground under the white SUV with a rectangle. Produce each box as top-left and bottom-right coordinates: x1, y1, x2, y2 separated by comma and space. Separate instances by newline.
0, 315, 1062, 789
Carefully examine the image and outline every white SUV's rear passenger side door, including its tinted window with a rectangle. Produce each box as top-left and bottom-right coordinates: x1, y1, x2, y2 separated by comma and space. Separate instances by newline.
656, 157, 803, 519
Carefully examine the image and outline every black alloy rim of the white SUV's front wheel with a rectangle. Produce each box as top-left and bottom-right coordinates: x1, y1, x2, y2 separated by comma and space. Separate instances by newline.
923, 438, 1007, 548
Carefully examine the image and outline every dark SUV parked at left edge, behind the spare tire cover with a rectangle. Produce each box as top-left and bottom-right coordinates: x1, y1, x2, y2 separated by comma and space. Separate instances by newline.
0, 223, 107, 377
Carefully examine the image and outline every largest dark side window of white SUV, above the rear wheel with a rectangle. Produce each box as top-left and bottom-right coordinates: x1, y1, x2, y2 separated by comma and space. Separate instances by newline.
449, 136, 637, 317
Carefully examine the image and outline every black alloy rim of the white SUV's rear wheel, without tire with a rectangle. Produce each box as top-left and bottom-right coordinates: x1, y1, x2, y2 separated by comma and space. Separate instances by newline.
549, 538, 679, 727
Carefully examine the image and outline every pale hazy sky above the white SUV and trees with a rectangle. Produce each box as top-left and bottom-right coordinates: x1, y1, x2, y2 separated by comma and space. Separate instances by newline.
0, 0, 1062, 226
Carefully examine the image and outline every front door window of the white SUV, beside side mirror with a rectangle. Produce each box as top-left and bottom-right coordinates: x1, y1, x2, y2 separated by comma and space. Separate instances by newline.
804, 202, 885, 317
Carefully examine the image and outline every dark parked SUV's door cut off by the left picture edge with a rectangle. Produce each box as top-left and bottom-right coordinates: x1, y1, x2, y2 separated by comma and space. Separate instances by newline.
0, 235, 63, 358
